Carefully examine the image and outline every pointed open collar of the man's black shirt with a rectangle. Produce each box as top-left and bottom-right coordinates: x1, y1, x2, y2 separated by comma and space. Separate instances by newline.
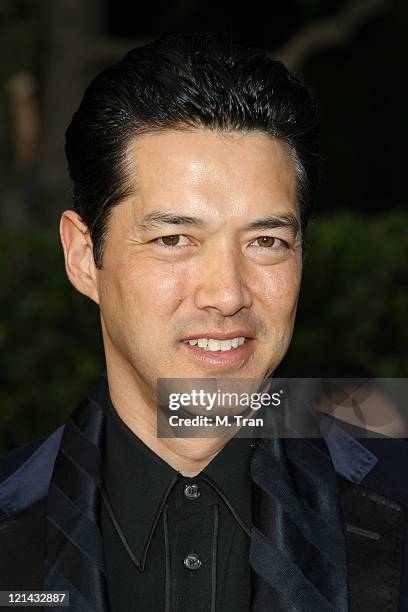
103, 398, 253, 570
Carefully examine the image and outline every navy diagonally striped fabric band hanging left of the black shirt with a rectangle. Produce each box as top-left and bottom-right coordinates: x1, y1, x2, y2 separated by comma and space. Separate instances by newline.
44, 377, 108, 612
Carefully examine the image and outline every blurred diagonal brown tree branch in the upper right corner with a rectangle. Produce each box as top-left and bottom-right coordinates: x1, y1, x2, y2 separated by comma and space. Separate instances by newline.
270, 0, 390, 73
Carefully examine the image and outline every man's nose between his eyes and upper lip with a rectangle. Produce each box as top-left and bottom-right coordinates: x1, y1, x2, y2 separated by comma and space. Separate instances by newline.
195, 245, 252, 317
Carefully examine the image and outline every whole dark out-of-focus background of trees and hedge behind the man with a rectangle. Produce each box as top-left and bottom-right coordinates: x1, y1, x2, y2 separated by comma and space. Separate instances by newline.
0, 0, 408, 451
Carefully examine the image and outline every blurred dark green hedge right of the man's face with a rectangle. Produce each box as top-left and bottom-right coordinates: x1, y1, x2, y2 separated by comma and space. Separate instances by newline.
282, 210, 408, 377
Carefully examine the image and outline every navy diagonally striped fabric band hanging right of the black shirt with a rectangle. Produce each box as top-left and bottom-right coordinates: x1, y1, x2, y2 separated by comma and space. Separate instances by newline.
250, 438, 348, 612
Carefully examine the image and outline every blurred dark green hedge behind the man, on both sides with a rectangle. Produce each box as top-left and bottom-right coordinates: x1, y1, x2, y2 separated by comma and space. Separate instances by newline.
0, 210, 408, 451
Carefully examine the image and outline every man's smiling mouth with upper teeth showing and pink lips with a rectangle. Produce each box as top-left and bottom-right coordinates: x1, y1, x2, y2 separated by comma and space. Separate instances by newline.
181, 330, 255, 367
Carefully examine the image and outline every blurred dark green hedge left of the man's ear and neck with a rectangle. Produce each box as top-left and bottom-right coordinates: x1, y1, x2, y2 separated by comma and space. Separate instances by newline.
0, 229, 104, 450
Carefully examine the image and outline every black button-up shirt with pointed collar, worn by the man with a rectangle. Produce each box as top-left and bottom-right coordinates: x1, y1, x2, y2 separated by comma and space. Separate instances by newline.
101, 402, 253, 612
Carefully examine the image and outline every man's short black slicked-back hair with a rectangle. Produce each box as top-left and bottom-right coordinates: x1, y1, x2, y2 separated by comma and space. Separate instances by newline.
65, 33, 320, 268
